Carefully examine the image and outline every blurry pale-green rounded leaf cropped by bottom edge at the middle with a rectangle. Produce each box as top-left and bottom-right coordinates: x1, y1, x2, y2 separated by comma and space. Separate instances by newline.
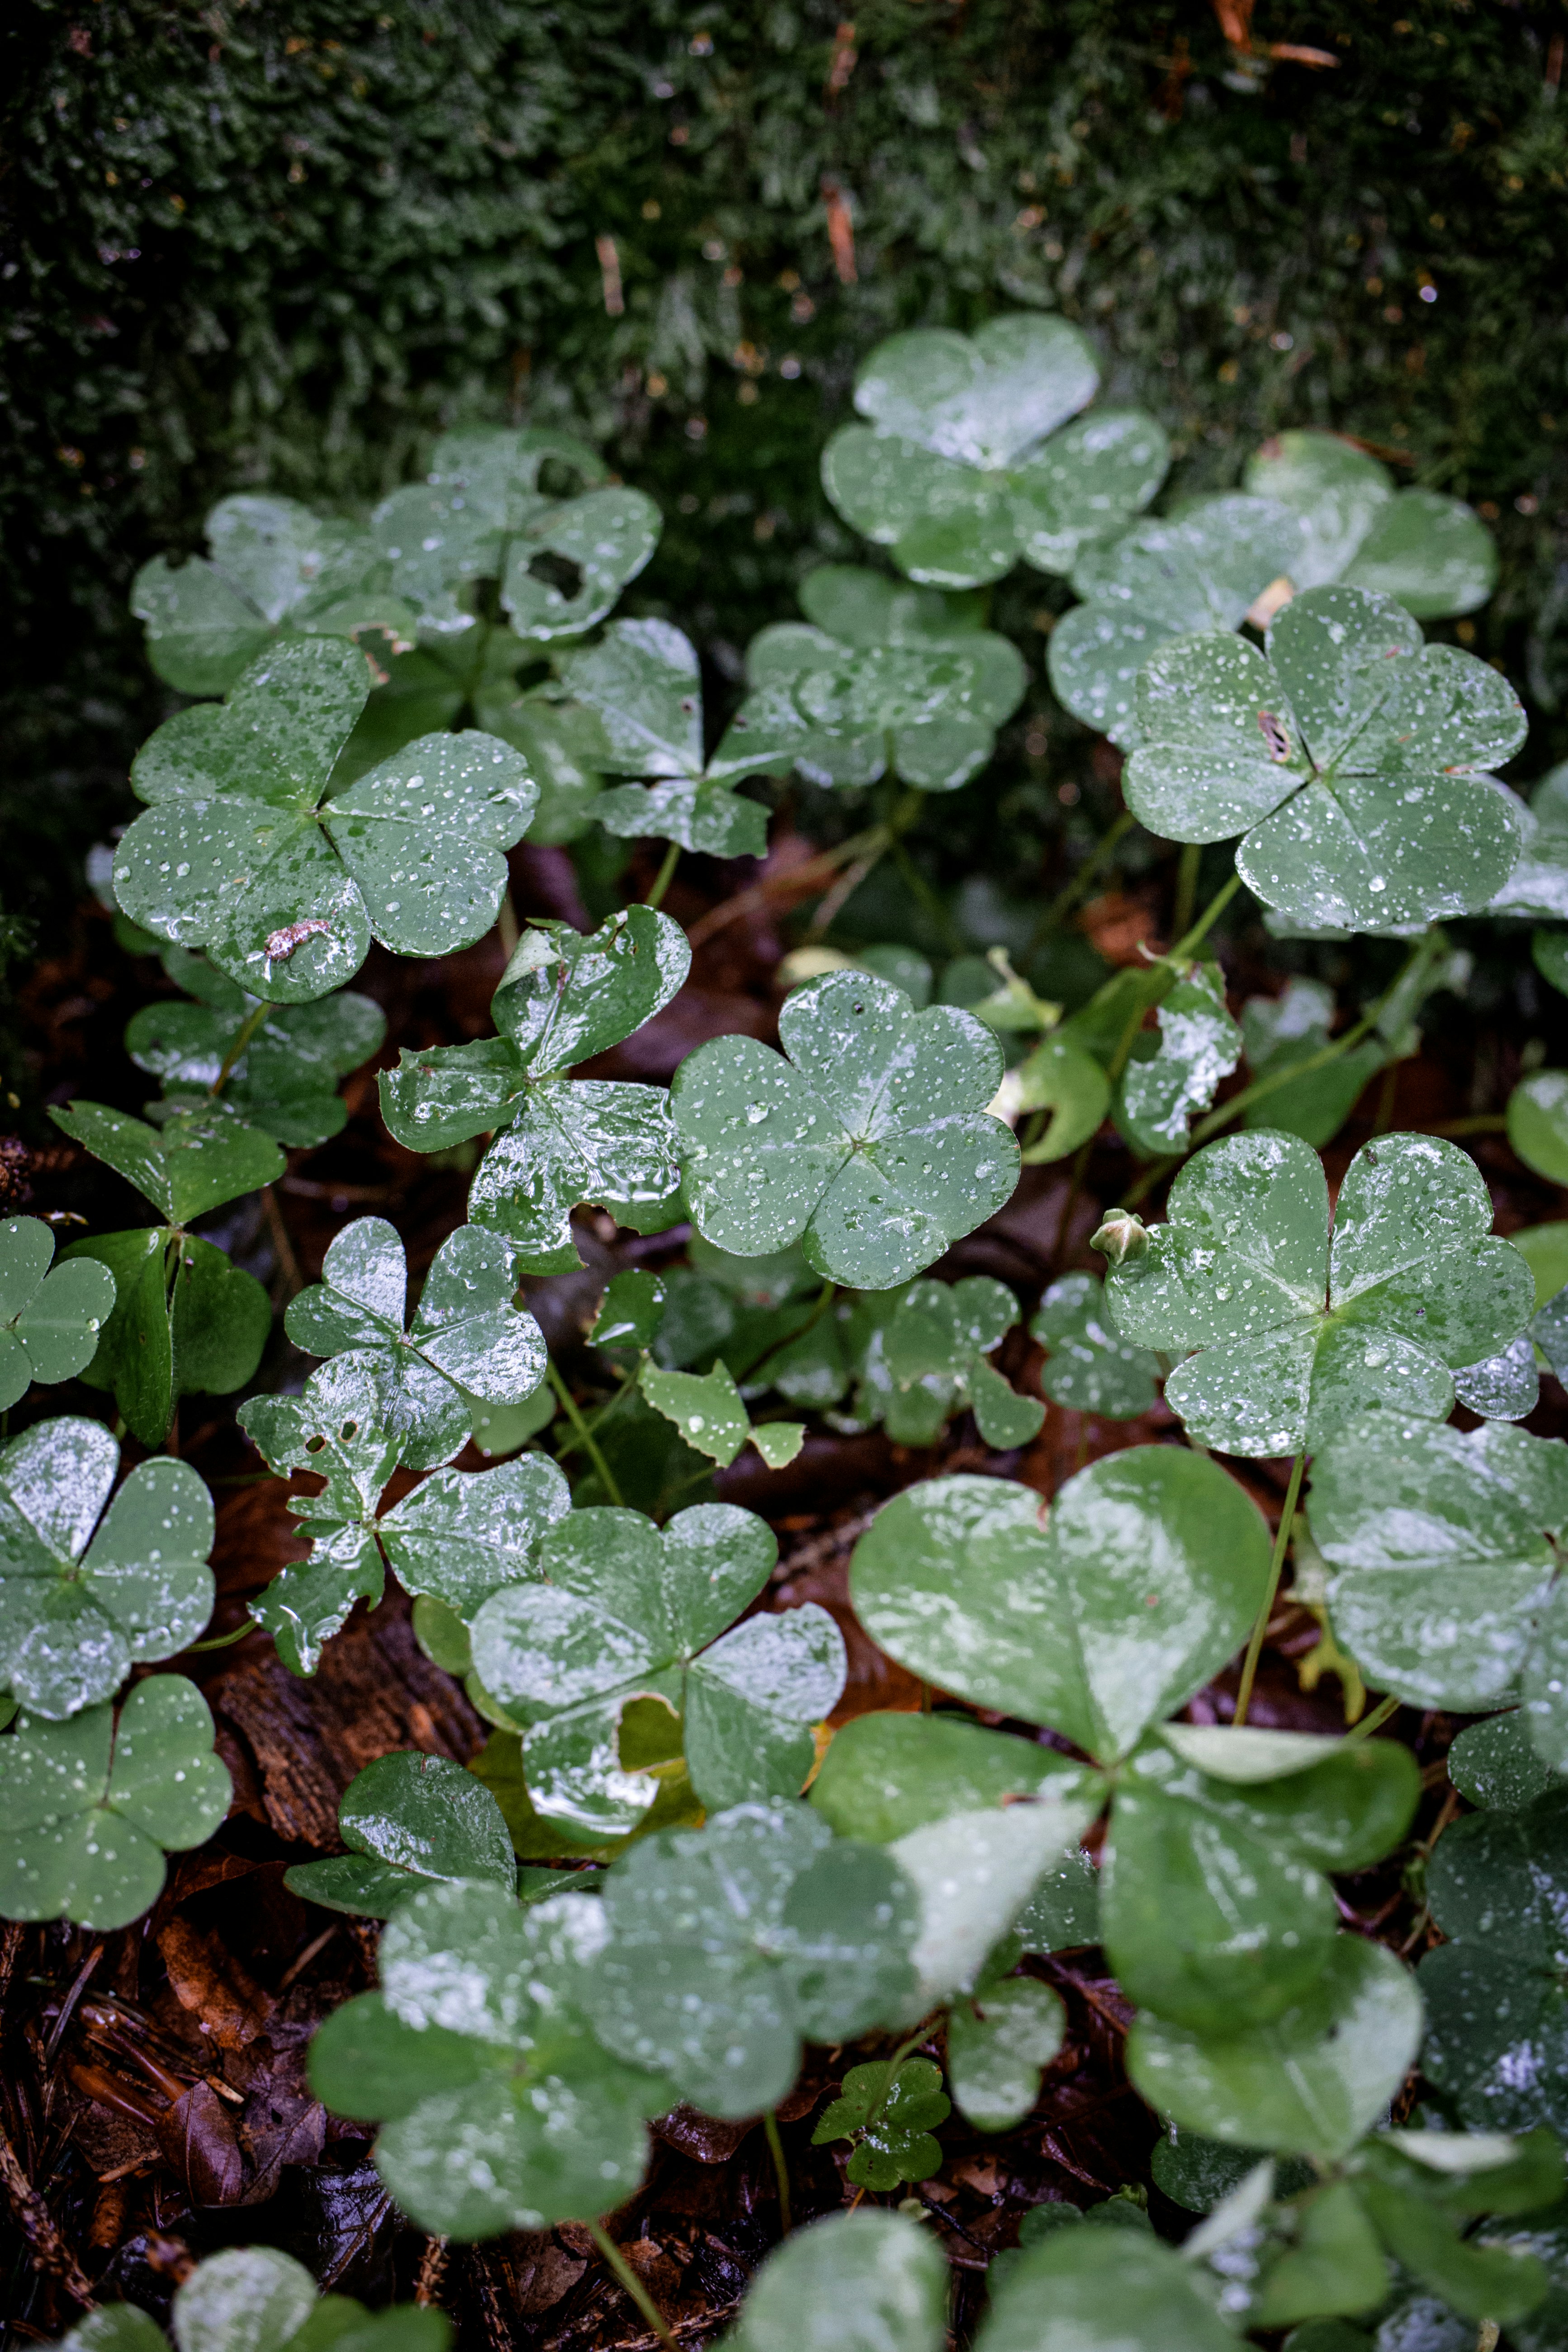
726, 2206, 947, 2352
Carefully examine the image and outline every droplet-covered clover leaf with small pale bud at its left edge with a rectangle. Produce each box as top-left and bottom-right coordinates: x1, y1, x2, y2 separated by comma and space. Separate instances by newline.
1103, 1129, 1535, 1456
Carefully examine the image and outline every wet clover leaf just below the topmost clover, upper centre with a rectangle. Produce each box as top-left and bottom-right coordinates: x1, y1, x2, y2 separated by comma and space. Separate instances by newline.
745, 564, 1027, 792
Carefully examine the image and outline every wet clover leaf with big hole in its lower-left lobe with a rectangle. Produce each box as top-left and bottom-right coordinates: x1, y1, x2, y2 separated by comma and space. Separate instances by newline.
473, 1503, 844, 1837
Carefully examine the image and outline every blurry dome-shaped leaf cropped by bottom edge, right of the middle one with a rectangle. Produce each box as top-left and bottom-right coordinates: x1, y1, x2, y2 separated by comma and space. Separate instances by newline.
976, 2227, 1236, 2352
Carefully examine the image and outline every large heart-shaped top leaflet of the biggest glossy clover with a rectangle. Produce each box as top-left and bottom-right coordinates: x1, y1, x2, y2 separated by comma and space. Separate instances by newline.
848, 1446, 1270, 1762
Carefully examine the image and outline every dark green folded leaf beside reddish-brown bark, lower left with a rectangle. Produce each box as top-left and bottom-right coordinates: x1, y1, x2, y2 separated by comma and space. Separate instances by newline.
284, 1748, 517, 1919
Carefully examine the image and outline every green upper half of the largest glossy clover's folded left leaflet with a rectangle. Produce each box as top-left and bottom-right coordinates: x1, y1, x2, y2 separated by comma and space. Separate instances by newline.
811, 1715, 1086, 1846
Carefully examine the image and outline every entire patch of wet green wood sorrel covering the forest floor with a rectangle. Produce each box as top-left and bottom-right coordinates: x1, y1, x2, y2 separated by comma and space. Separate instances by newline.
12, 343, 1568, 2352
